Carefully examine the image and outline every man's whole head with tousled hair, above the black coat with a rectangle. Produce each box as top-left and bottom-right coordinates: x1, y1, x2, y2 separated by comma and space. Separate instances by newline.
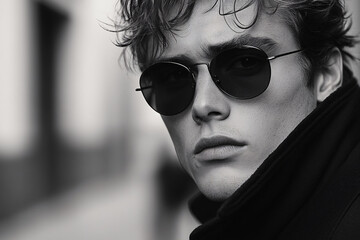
114, 0, 353, 200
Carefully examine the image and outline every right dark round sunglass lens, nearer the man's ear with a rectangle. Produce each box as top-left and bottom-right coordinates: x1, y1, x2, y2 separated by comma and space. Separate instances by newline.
211, 48, 271, 99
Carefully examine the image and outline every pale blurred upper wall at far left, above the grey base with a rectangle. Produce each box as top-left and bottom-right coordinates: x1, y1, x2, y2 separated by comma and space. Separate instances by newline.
0, 0, 36, 157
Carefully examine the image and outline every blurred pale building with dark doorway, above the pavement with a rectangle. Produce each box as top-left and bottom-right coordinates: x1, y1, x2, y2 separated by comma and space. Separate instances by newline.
0, 0, 127, 217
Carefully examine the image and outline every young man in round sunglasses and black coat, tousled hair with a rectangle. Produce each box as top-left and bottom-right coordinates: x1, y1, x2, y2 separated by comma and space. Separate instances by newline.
117, 0, 360, 240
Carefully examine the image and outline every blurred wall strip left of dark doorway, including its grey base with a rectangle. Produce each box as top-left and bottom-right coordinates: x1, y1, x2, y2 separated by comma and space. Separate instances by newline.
0, 0, 44, 218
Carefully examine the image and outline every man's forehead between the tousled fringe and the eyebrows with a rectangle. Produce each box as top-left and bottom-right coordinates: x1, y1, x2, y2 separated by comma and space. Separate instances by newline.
159, 0, 295, 61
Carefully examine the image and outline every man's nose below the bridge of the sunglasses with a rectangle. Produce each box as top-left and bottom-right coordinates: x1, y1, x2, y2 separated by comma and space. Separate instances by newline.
192, 65, 230, 124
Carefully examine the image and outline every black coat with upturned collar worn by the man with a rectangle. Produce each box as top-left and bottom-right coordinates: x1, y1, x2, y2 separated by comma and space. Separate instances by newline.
190, 68, 360, 240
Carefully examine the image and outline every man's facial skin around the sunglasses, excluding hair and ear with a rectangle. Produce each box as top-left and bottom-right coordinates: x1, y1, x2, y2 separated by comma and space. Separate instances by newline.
160, 1, 316, 200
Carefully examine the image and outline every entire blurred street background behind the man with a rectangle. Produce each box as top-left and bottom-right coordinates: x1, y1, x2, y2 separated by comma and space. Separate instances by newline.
0, 0, 360, 240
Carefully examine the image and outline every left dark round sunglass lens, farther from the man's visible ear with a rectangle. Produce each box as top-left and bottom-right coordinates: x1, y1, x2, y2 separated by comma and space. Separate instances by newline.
140, 62, 194, 115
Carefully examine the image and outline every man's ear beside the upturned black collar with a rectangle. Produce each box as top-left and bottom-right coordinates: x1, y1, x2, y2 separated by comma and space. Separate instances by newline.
314, 47, 343, 102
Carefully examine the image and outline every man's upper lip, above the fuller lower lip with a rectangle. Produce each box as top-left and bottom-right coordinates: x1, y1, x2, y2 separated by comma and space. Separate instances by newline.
194, 136, 246, 154
